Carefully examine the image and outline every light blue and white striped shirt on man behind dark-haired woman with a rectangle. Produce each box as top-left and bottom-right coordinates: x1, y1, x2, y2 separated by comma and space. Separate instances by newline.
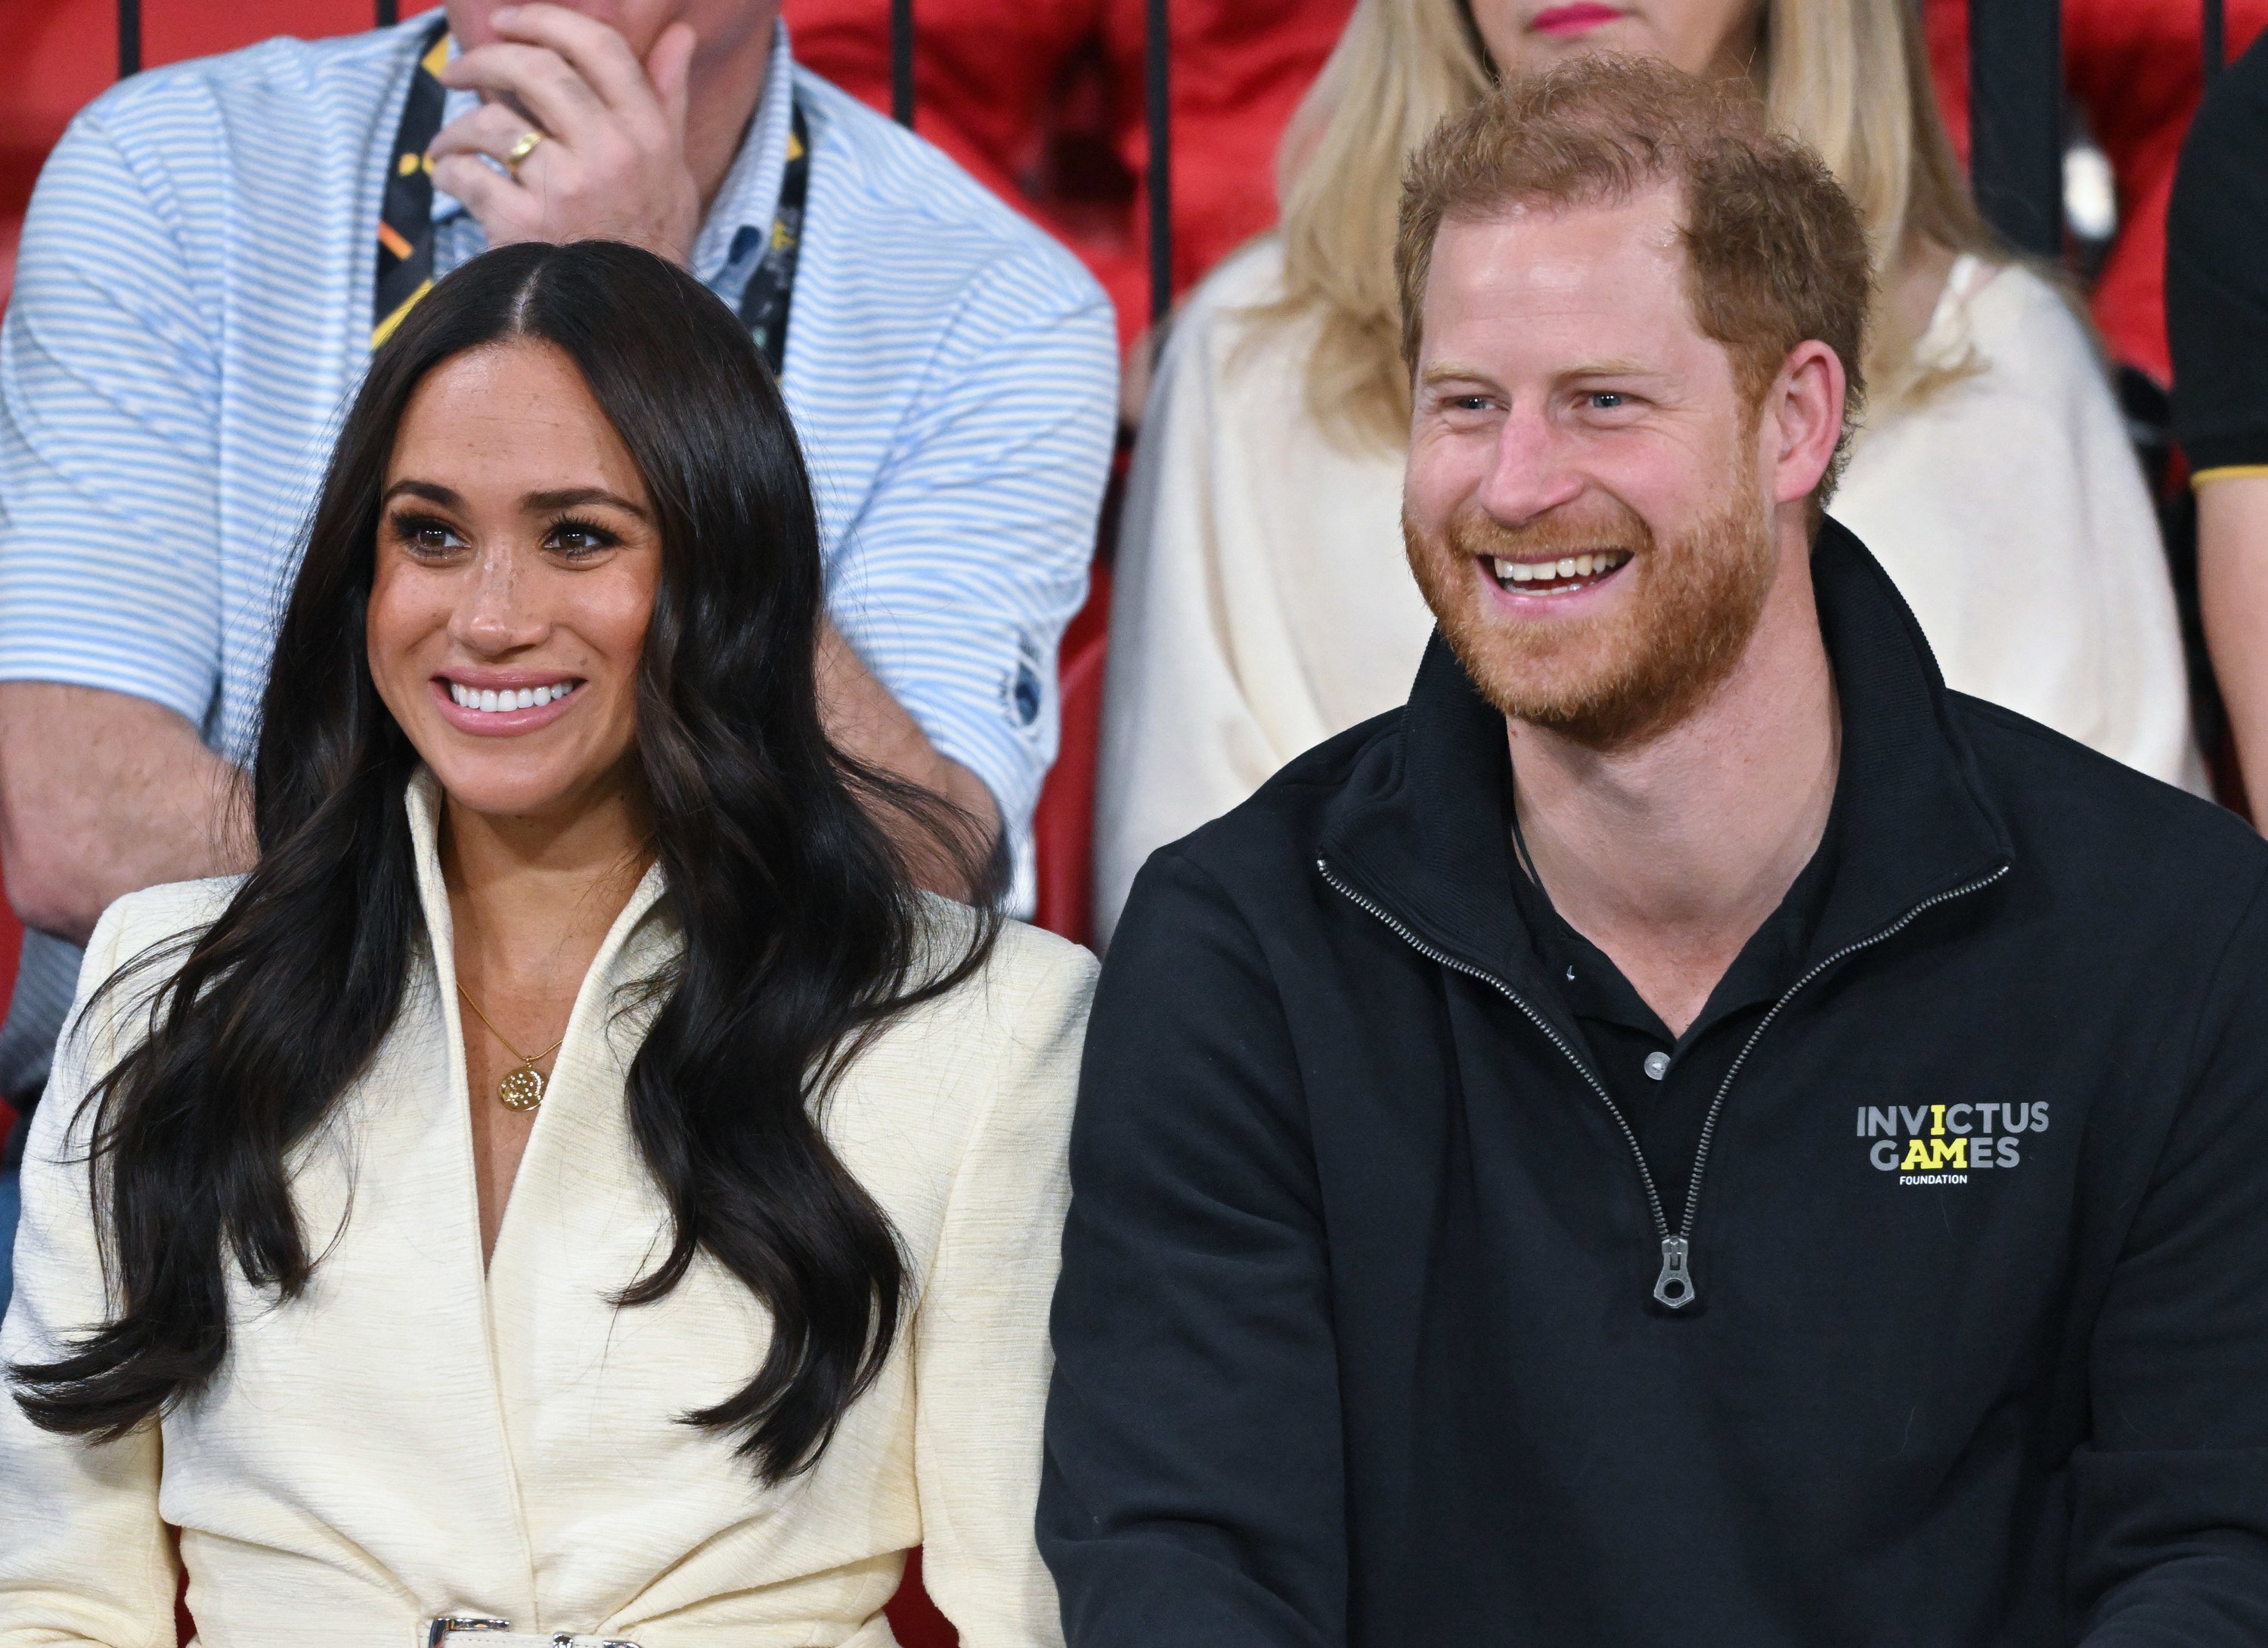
0, 16, 1118, 902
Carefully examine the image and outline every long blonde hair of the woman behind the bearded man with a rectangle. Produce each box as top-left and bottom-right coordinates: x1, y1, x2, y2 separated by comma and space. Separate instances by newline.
1261, 0, 2007, 447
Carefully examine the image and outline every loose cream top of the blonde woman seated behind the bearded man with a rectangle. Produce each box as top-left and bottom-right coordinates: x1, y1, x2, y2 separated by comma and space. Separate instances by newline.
1095, 236, 2204, 940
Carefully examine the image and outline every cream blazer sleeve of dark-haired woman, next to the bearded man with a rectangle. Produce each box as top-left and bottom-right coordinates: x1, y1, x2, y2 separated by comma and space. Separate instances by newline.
914, 934, 1095, 1648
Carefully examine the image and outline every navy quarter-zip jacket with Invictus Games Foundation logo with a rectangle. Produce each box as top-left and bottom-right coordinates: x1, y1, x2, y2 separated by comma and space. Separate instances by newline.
1039, 524, 2268, 1648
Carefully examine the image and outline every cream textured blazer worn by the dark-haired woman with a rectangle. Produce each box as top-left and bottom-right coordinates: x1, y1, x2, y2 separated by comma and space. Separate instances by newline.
0, 778, 1095, 1648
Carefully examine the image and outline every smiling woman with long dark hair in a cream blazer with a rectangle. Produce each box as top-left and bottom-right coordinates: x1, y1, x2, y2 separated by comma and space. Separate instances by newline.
0, 243, 1093, 1648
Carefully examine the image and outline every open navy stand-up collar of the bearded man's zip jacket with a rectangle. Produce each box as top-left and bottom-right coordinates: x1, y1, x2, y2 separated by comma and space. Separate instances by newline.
1318, 522, 2009, 1006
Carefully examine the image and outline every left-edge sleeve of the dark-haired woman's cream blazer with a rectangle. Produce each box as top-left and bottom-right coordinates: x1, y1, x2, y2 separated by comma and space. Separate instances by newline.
0, 904, 179, 1648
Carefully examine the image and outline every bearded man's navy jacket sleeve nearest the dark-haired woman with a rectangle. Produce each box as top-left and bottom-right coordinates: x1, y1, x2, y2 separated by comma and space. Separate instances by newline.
1039, 847, 1347, 1648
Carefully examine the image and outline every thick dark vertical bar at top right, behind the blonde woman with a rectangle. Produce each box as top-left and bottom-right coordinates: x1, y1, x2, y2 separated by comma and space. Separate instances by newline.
1969, 0, 2064, 259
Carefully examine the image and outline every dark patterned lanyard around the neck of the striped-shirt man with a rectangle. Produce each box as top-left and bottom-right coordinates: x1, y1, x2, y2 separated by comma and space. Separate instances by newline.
370, 20, 812, 376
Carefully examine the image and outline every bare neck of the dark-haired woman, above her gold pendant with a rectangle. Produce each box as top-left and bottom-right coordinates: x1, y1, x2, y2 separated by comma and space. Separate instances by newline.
440, 787, 653, 1011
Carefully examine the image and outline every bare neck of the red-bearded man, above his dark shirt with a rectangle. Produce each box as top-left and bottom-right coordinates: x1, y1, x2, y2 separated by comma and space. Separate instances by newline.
1506, 542, 1842, 1033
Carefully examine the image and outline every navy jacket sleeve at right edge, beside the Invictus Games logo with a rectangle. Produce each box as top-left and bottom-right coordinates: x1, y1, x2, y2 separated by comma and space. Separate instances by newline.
2071, 866, 2268, 1648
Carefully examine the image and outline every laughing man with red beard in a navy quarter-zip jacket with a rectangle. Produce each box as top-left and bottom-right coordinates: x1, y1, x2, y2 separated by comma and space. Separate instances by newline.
1039, 61, 2268, 1648
